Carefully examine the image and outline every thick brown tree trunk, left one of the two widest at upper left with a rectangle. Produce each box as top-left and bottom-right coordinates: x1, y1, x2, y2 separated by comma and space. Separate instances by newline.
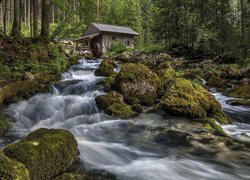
11, 0, 21, 36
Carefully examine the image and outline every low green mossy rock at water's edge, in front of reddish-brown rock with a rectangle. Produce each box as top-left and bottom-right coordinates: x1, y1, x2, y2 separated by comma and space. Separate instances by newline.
106, 103, 137, 119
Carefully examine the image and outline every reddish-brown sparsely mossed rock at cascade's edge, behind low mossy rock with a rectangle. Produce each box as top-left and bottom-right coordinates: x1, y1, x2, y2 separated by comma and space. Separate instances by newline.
95, 91, 125, 110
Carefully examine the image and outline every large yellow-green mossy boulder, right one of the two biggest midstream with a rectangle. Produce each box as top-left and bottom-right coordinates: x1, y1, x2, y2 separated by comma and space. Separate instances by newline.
160, 78, 221, 118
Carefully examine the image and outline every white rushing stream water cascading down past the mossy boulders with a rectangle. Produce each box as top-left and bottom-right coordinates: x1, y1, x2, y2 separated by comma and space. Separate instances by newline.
1, 60, 250, 180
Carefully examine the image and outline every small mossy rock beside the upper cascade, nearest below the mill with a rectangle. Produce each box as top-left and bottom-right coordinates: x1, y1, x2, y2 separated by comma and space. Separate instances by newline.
95, 60, 115, 76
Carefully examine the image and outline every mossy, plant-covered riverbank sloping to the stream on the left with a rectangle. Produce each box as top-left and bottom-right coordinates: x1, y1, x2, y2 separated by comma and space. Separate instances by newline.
0, 34, 79, 135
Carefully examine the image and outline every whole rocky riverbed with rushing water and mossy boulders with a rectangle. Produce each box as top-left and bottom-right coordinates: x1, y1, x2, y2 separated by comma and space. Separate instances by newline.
0, 54, 250, 179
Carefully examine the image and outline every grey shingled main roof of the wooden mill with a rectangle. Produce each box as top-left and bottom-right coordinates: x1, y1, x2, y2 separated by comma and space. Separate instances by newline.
92, 23, 139, 35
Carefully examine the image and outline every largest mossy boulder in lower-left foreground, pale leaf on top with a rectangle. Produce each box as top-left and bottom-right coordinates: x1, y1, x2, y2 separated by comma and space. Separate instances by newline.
3, 129, 79, 179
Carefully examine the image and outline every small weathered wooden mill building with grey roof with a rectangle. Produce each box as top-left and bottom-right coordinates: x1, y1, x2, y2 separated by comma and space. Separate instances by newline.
75, 23, 139, 55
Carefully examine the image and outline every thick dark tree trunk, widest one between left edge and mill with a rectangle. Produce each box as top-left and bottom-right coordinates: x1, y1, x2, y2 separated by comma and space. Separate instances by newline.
41, 0, 52, 42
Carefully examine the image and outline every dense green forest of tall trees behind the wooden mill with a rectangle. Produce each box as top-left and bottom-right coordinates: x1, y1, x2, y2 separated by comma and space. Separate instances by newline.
0, 0, 250, 58
